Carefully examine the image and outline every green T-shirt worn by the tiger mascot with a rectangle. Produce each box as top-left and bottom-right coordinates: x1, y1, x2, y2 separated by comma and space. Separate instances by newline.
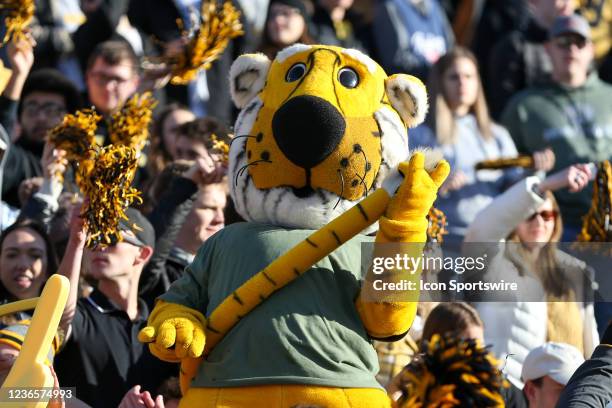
161, 223, 380, 388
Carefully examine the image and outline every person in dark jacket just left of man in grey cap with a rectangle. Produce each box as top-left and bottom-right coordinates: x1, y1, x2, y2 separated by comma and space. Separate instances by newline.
486, 0, 575, 120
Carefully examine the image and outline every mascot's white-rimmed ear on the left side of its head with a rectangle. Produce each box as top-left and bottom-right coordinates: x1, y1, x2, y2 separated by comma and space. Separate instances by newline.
230, 54, 271, 109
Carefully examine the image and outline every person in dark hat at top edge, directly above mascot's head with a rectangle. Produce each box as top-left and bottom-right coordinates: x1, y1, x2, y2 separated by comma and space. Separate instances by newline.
259, 0, 314, 59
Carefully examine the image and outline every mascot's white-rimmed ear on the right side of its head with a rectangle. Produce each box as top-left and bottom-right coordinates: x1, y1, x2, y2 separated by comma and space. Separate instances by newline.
385, 74, 428, 128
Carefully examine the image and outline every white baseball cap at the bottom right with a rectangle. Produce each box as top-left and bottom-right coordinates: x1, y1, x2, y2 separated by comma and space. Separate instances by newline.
521, 342, 584, 385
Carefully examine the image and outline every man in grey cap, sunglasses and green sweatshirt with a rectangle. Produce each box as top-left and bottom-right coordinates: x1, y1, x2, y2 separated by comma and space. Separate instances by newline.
501, 15, 612, 241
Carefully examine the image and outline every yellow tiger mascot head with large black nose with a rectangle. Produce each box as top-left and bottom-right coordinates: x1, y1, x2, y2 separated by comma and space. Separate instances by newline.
229, 44, 427, 229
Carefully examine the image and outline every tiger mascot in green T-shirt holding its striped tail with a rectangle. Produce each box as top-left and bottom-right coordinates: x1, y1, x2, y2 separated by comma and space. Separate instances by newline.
140, 44, 449, 408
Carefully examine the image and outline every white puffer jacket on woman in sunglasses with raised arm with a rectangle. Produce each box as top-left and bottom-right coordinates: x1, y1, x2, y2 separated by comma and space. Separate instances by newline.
464, 176, 599, 388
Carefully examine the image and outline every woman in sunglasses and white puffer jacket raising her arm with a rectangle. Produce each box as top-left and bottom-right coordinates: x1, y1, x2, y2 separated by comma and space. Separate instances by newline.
464, 164, 599, 388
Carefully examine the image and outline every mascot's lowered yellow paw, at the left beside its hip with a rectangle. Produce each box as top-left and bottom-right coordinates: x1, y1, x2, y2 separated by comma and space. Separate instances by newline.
138, 300, 206, 362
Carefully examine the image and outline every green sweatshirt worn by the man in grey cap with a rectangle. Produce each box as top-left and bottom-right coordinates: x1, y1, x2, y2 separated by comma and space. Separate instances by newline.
502, 74, 612, 227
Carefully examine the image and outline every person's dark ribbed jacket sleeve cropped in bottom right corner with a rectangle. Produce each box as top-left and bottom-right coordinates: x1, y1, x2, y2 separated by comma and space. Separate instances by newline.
557, 320, 612, 408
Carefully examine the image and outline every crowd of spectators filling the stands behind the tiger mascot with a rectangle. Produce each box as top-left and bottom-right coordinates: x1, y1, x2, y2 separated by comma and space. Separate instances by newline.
0, 0, 612, 408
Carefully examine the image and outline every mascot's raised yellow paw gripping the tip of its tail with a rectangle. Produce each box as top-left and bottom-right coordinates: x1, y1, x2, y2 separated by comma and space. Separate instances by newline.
385, 152, 450, 223
